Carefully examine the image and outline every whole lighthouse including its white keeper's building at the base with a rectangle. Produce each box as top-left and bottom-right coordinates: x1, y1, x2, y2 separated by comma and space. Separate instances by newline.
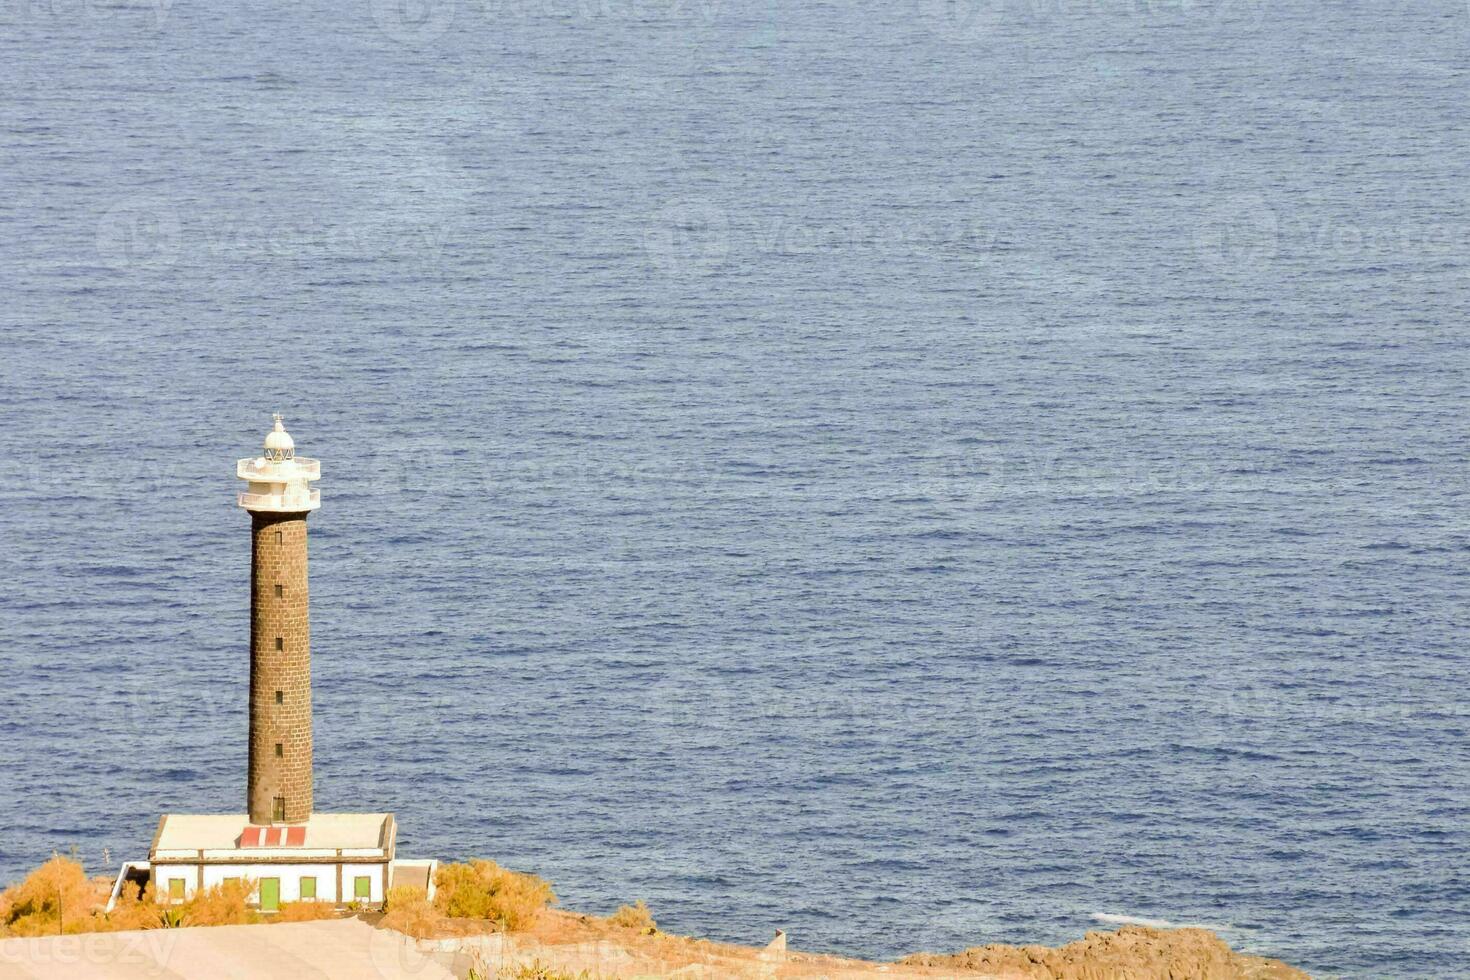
109, 414, 438, 914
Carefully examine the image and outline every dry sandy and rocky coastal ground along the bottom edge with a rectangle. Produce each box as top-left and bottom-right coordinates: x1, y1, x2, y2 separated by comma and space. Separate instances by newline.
0, 911, 1307, 980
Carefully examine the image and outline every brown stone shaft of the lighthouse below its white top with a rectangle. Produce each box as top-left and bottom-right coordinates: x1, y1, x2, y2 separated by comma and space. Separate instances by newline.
247, 514, 312, 824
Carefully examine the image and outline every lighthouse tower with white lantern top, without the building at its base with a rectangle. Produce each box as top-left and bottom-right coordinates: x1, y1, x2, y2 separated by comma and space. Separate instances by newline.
235, 416, 322, 824
